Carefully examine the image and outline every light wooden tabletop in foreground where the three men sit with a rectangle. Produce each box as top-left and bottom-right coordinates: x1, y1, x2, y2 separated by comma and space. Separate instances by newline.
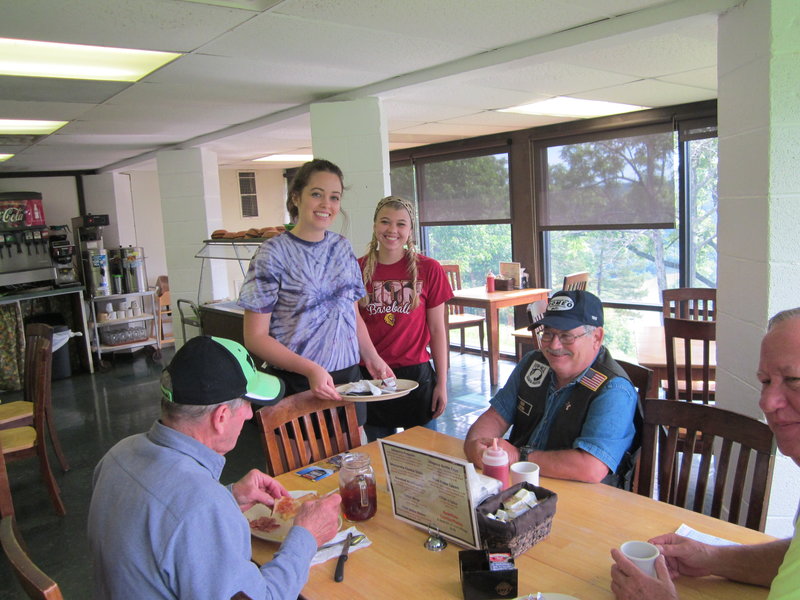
253, 427, 773, 600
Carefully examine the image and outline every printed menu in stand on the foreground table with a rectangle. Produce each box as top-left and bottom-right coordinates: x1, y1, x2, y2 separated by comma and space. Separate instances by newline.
378, 439, 480, 548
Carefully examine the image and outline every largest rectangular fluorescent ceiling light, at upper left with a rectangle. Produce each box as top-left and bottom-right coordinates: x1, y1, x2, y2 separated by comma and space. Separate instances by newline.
0, 38, 181, 81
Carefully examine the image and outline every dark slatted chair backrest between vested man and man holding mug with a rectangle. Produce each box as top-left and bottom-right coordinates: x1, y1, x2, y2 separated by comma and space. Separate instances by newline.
637, 398, 775, 531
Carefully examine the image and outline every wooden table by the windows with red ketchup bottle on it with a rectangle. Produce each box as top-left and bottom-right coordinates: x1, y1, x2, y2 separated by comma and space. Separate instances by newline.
445, 287, 550, 385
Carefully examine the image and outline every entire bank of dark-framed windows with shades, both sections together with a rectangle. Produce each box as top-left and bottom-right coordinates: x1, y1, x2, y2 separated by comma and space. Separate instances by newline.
391, 102, 717, 360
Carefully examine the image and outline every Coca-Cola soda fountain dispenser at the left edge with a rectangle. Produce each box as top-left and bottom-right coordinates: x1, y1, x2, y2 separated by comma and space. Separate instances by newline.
0, 192, 55, 286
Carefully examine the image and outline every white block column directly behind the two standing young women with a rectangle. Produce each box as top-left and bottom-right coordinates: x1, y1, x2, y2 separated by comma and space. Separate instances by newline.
311, 98, 390, 256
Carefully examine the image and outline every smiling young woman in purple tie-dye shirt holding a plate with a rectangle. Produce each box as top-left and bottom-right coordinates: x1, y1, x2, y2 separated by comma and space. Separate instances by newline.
238, 159, 392, 408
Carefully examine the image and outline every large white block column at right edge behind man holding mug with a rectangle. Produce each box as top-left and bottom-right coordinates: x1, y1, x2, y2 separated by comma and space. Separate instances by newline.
717, 0, 800, 535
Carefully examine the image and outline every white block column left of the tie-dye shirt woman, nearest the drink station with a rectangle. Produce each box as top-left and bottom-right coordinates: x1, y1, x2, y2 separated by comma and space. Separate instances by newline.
156, 148, 228, 348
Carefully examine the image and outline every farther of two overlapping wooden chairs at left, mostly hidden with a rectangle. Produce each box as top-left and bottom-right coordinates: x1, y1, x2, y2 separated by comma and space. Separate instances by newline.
0, 323, 69, 471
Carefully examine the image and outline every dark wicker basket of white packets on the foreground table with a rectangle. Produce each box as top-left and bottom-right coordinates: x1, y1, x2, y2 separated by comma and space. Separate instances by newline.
475, 482, 558, 558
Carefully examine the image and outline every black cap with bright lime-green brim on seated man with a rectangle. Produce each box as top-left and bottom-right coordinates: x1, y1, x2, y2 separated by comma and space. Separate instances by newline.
161, 336, 284, 406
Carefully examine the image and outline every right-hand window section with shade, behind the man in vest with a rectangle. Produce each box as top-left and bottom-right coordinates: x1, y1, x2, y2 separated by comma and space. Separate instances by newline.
537, 120, 717, 357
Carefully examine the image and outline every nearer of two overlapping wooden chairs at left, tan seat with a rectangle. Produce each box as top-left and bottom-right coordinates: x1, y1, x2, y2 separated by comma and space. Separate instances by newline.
0, 332, 67, 516
